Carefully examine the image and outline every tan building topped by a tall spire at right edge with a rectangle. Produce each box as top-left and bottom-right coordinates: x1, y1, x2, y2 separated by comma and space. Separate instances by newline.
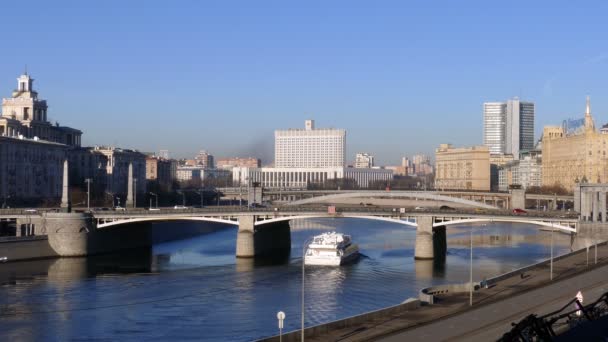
542, 97, 608, 190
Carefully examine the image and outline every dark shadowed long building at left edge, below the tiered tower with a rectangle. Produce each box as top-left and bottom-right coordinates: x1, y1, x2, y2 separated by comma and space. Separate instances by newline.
0, 136, 69, 205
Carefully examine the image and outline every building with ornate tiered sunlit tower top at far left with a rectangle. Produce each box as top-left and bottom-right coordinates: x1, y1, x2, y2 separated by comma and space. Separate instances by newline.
0, 73, 82, 147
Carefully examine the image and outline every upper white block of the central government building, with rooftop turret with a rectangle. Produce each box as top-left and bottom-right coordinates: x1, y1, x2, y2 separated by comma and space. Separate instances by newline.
274, 120, 346, 168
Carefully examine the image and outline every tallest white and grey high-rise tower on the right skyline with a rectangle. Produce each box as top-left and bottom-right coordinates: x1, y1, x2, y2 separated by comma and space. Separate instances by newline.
483, 98, 534, 158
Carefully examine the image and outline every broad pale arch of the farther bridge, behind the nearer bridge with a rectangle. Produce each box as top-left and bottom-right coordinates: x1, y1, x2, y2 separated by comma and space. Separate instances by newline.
287, 191, 497, 209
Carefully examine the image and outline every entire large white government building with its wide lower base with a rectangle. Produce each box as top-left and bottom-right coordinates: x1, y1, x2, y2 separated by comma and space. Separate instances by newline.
232, 120, 393, 189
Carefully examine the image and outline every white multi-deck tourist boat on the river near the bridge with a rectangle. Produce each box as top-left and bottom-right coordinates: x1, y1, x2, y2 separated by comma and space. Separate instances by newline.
304, 232, 359, 266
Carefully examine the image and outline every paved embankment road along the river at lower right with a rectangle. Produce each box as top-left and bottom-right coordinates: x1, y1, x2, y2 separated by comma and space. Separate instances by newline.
307, 245, 608, 341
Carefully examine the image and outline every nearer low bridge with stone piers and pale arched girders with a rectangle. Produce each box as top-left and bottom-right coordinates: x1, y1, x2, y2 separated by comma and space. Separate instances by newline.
0, 206, 578, 259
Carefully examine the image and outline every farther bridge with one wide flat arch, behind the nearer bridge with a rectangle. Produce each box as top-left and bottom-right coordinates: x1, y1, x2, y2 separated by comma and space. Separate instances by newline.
217, 187, 574, 210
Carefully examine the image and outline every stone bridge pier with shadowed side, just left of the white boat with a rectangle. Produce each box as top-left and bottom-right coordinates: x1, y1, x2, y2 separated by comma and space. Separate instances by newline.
236, 215, 291, 258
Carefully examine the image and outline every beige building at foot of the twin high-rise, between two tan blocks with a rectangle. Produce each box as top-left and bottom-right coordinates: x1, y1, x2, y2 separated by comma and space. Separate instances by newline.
498, 150, 542, 191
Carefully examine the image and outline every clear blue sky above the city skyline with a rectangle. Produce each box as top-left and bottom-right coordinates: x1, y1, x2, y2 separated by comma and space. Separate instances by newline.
0, 0, 608, 165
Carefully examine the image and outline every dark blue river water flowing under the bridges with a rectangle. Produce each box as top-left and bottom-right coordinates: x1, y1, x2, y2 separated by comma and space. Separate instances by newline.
0, 219, 571, 341
